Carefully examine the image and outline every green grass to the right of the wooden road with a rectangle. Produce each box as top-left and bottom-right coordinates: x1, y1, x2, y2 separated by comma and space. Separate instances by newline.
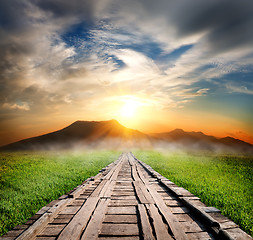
134, 151, 253, 236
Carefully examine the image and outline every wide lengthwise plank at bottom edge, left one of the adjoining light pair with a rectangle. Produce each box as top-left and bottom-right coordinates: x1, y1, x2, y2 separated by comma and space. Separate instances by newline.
58, 197, 99, 240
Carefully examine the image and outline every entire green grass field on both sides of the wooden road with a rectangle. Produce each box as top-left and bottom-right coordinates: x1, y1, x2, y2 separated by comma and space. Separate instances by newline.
0, 151, 253, 236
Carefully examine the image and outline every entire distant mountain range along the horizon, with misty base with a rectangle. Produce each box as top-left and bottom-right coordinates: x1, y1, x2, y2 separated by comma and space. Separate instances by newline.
0, 120, 253, 154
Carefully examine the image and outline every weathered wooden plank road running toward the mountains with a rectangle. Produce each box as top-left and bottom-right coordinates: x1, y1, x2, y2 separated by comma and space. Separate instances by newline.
0, 153, 252, 240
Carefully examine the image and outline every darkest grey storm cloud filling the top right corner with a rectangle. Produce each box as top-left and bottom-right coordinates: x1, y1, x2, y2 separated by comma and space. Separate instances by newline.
173, 0, 253, 51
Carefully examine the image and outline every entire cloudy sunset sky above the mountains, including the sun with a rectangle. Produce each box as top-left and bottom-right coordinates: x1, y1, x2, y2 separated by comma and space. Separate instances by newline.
0, 0, 253, 145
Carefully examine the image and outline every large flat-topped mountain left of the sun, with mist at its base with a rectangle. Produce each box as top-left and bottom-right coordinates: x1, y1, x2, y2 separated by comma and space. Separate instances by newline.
0, 120, 152, 151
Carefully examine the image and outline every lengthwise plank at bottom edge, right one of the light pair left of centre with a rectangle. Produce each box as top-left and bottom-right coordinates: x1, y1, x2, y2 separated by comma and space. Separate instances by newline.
81, 199, 109, 240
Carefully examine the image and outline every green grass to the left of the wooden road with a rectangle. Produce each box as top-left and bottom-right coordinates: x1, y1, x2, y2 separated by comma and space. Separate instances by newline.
0, 151, 119, 236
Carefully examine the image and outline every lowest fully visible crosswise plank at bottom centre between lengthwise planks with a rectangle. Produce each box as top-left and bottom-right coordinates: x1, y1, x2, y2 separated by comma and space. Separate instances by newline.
100, 224, 139, 236
